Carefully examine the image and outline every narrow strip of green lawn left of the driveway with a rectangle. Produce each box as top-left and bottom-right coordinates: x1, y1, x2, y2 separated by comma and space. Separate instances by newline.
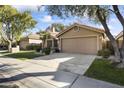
1, 51, 42, 60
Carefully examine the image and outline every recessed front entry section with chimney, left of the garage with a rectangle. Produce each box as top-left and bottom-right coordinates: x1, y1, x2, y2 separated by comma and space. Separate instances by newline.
45, 26, 59, 48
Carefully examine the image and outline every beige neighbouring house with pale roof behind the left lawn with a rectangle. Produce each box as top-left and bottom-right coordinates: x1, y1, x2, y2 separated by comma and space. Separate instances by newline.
19, 34, 42, 49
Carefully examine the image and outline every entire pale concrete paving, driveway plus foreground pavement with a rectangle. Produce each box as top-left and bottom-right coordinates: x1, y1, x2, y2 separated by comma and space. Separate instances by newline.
0, 53, 122, 88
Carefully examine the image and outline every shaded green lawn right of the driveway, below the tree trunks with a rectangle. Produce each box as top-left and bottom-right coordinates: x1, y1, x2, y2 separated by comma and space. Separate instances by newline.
84, 59, 124, 85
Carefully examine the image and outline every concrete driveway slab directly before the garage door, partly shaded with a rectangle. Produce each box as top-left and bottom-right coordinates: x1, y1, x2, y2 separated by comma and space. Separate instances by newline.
30, 53, 96, 75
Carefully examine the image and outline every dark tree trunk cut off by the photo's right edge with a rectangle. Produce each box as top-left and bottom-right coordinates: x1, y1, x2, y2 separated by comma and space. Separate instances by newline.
113, 5, 124, 68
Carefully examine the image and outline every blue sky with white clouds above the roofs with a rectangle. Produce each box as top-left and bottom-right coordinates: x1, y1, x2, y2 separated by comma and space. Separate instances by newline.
13, 5, 122, 36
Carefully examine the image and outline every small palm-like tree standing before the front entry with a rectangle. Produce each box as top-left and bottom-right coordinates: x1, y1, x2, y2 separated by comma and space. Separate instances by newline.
37, 30, 50, 48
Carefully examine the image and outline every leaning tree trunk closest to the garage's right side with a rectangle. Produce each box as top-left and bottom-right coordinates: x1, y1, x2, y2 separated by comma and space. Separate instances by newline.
96, 6, 121, 62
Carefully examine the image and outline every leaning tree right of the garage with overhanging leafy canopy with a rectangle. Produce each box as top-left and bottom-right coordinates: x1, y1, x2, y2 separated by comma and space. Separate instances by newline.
46, 5, 124, 66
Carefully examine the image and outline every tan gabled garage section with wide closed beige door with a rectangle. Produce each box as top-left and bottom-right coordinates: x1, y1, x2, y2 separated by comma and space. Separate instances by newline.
57, 23, 105, 54
